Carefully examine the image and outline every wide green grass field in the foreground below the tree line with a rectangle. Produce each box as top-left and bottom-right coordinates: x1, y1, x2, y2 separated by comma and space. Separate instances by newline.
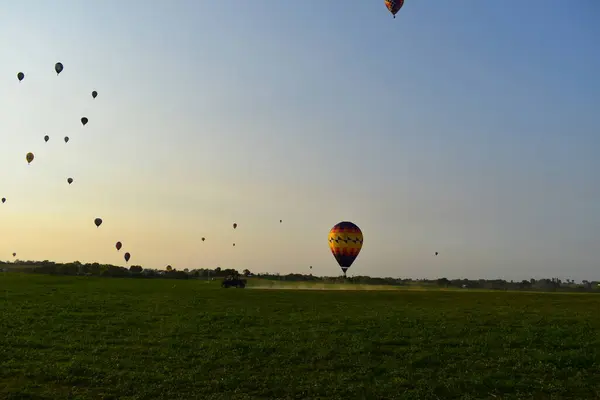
0, 273, 600, 399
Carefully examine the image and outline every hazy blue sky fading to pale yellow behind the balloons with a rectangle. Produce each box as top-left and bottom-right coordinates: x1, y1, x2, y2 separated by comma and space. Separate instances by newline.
0, 0, 600, 280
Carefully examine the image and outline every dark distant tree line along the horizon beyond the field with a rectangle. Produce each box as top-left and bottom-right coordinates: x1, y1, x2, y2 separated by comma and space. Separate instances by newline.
0, 260, 600, 293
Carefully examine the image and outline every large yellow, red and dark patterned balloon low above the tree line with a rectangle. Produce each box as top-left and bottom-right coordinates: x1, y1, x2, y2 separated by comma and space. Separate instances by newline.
329, 221, 363, 277
